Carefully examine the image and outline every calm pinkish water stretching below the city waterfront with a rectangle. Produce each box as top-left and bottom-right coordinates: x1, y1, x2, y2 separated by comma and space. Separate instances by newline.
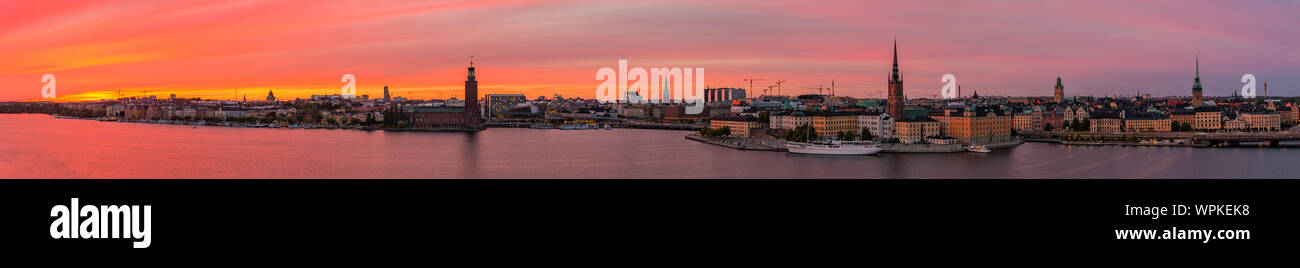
0, 114, 1300, 178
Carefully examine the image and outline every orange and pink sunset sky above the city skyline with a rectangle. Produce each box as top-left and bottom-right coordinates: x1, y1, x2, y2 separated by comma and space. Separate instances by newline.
0, 0, 1300, 101
